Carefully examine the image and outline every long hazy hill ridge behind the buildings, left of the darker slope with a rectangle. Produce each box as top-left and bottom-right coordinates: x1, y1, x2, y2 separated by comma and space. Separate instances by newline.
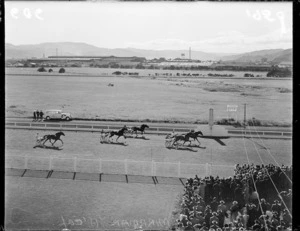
5, 42, 232, 60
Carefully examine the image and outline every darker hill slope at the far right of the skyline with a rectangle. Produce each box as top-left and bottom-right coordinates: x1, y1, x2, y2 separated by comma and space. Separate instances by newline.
221, 49, 292, 64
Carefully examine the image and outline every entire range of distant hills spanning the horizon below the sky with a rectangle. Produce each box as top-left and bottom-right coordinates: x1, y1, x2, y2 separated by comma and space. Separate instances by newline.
5, 42, 292, 64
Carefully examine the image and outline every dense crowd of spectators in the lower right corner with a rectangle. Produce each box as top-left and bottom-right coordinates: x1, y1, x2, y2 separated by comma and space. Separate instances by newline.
176, 164, 292, 231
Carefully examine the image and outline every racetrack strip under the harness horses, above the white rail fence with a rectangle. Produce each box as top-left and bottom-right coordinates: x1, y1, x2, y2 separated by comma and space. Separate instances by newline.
5, 129, 292, 177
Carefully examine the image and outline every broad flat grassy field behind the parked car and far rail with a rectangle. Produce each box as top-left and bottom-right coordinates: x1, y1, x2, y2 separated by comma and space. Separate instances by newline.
5, 68, 292, 125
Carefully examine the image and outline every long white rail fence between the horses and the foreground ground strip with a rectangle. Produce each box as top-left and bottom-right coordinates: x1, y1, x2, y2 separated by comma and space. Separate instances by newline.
5, 155, 234, 178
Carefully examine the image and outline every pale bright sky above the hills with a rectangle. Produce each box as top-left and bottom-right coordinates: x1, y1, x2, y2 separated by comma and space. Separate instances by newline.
5, 1, 293, 53
